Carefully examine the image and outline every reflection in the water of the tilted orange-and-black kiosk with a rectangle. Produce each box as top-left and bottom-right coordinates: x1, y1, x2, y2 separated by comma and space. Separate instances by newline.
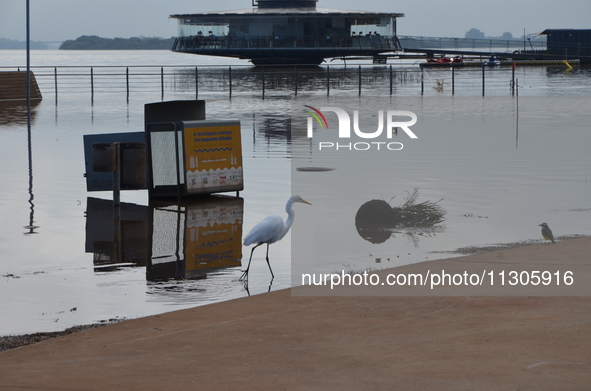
86, 196, 244, 281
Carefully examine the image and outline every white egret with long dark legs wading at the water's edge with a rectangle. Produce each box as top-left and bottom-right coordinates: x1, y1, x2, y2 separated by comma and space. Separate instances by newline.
240, 195, 312, 280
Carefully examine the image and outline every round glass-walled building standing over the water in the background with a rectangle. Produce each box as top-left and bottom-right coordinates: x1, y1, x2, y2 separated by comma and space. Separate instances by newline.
170, 0, 404, 65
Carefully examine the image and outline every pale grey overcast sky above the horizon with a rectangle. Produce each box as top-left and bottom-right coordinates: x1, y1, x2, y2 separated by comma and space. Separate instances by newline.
0, 0, 591, 41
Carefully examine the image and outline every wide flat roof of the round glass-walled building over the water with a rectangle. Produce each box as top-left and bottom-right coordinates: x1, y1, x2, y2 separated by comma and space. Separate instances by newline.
170, 8, 404, 19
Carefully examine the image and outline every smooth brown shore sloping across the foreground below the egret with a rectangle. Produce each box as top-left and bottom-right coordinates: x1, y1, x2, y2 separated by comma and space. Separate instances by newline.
0, 238, 591, 390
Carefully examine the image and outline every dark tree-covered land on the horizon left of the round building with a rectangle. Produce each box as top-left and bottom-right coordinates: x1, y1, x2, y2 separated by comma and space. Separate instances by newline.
60, 35, 174, 50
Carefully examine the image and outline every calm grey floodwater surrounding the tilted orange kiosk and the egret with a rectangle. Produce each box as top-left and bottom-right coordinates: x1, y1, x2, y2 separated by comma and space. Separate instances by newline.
0, 51, 591, 335
